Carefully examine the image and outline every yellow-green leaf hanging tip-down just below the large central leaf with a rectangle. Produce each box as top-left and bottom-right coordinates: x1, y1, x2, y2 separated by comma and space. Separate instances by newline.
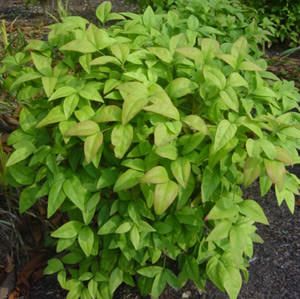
111, 124, 133, 159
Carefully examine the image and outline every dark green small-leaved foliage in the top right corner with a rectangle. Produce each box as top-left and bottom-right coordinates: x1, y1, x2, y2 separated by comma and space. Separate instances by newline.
243, 0, 300, 46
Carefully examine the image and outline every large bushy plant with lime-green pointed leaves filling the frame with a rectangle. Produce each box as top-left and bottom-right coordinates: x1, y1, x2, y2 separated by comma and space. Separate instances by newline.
2, 1, 300, 299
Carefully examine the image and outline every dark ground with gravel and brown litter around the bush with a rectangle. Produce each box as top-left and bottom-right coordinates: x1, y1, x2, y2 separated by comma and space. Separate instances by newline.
0, 0, 300, 299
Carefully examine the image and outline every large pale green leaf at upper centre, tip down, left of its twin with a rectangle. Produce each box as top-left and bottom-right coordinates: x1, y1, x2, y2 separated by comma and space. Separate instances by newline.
118, 82, 148, 125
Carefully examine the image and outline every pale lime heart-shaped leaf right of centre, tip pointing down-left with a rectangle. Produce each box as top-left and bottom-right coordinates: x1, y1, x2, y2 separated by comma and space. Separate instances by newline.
213, 119, 237, 152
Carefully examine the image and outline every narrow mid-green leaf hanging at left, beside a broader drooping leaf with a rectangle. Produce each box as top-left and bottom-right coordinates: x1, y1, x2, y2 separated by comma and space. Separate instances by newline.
47, 173, 66, 218
